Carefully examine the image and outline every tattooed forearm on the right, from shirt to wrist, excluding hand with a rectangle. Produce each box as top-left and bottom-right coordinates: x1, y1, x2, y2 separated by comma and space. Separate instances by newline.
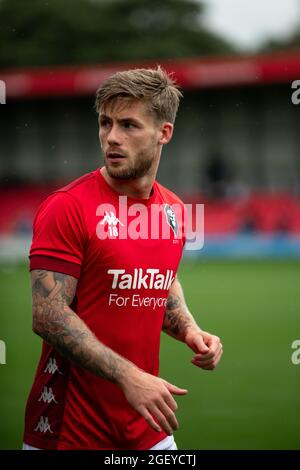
162, 278, 200, 342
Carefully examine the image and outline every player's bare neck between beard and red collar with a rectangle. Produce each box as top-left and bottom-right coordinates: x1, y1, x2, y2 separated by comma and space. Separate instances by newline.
100, 167, 156, 199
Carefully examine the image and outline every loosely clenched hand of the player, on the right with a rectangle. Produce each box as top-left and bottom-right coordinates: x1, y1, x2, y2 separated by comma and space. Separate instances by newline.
185, 329, 223, 370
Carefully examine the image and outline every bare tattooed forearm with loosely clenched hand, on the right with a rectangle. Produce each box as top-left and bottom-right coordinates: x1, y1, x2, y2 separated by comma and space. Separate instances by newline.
162, 278, 223, 370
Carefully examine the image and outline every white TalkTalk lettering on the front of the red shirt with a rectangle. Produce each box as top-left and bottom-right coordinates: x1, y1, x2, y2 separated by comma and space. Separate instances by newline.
107, 268, 175, 290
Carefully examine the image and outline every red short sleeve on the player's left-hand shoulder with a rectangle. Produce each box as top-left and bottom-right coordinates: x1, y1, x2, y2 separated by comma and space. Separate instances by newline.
29, 192, 85, 278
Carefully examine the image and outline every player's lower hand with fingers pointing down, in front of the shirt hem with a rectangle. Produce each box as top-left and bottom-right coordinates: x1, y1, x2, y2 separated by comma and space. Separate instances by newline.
121, 369, 187, 435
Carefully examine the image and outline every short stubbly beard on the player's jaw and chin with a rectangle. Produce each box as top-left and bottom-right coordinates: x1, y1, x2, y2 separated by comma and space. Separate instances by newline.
104, 149, 155, 180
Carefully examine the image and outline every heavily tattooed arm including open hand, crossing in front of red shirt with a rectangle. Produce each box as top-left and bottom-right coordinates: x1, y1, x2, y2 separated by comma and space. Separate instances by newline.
31, 270, 187, 434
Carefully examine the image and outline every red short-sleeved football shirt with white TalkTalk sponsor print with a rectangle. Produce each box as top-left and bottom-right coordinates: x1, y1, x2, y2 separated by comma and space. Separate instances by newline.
24, 169, 184, 450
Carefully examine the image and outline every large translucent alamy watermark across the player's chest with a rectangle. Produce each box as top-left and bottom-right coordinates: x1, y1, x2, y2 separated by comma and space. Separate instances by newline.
96, 196, 204, 250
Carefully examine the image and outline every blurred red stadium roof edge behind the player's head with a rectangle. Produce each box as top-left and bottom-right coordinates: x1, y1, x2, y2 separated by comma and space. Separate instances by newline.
0, 51, 300, 98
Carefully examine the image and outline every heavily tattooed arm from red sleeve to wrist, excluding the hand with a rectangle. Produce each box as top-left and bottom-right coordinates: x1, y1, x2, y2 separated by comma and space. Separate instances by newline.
31, 270, 133, 383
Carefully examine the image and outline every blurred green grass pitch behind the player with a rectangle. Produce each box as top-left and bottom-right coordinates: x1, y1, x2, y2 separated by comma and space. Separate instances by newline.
0, 261, 300, 449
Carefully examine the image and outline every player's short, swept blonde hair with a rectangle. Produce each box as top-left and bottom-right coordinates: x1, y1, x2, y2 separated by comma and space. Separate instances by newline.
95, 66, 182, 123
